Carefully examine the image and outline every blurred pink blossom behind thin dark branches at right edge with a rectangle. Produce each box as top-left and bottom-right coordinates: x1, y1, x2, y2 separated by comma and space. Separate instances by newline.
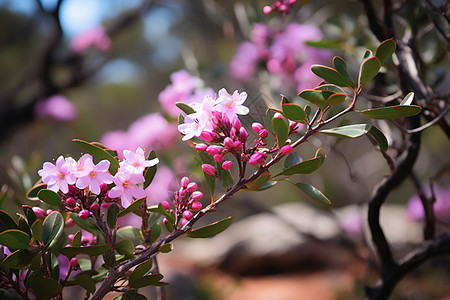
406, 187, 450, 221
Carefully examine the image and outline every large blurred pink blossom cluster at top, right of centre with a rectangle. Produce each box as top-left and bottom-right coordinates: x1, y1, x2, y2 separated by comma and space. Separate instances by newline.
229, 22, 331, 92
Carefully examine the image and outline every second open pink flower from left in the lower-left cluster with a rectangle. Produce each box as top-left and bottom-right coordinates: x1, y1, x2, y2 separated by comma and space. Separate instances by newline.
75, 156, 113, 195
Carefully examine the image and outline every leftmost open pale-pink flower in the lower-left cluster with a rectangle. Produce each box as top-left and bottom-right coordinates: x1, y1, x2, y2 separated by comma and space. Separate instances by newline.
38, 156, 76, 194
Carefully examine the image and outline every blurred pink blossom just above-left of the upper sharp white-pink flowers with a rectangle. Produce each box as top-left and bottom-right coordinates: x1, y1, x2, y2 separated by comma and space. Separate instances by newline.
158, 70, 203, 117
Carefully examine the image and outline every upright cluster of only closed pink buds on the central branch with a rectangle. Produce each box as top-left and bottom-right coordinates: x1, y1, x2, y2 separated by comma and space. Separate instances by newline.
161, 177, 203, 226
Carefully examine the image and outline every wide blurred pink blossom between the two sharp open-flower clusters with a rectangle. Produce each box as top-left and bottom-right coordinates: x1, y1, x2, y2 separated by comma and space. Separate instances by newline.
100, 113, 178, 158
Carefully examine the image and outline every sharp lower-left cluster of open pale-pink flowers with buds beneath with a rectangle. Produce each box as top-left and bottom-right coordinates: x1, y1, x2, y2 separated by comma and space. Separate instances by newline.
38, 148, 158, 219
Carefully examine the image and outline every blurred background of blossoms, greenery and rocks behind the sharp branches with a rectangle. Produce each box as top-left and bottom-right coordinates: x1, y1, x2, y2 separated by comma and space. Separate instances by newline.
0, 0, 450, 299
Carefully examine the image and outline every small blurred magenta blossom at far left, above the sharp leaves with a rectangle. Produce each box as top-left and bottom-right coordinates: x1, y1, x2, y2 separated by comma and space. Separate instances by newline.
35, 95, 78, 122
